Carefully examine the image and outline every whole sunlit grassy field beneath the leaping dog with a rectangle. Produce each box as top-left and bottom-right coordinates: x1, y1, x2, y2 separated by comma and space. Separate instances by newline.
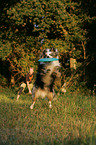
0, 88, 96, 145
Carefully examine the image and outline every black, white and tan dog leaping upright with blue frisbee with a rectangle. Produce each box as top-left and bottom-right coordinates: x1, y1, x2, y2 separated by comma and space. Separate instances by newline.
30, 48, 61, 109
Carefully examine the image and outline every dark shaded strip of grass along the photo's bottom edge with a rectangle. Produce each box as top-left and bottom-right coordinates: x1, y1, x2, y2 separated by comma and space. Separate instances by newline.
0, 128, 96, 145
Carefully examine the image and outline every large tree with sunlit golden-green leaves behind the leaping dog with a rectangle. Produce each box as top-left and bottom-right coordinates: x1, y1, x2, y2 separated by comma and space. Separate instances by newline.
0, 0, 89, 87
